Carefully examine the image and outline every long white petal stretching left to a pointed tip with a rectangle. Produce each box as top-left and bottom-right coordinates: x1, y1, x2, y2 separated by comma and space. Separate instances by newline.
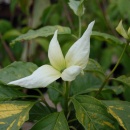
8, 65, 61, 88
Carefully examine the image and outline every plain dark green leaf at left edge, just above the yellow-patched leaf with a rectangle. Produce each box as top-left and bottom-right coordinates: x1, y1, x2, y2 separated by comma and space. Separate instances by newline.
0, 84, 25, 101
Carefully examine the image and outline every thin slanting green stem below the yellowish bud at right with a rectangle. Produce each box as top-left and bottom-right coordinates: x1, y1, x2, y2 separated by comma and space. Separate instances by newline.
95, 42, 129, 97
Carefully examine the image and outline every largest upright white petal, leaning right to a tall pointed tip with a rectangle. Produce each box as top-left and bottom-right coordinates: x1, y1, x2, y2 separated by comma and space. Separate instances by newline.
65, 21, 94, 69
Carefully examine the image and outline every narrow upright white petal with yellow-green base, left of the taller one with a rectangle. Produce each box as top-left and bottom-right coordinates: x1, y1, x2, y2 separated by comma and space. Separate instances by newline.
48, 30, 65, 71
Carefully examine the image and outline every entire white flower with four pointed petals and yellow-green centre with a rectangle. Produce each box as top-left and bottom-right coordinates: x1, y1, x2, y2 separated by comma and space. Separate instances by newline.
8, 21, 94, 88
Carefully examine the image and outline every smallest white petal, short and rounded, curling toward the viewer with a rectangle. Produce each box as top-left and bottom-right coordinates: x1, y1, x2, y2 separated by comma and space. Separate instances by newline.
61, 66, 82, 81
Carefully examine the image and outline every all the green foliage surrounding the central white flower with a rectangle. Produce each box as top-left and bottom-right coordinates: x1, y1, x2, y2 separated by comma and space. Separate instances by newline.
0, 0, 130, 130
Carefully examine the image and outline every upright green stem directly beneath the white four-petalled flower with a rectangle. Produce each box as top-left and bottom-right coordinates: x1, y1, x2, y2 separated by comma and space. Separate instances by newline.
64, 82, 69, 117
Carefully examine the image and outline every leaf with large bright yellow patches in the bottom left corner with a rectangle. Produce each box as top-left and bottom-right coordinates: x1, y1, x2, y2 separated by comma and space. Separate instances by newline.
0, 101, 34, 130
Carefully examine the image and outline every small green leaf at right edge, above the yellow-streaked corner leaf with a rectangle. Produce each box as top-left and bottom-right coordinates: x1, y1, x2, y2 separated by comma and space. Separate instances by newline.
113, 75, 130, 87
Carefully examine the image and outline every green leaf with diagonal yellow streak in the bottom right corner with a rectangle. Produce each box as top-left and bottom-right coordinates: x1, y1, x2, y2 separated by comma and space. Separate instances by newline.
103, 101, 130, 130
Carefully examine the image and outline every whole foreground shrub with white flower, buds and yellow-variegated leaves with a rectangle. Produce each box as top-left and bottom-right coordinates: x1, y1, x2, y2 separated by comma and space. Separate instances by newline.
0, 0, 130, 130
